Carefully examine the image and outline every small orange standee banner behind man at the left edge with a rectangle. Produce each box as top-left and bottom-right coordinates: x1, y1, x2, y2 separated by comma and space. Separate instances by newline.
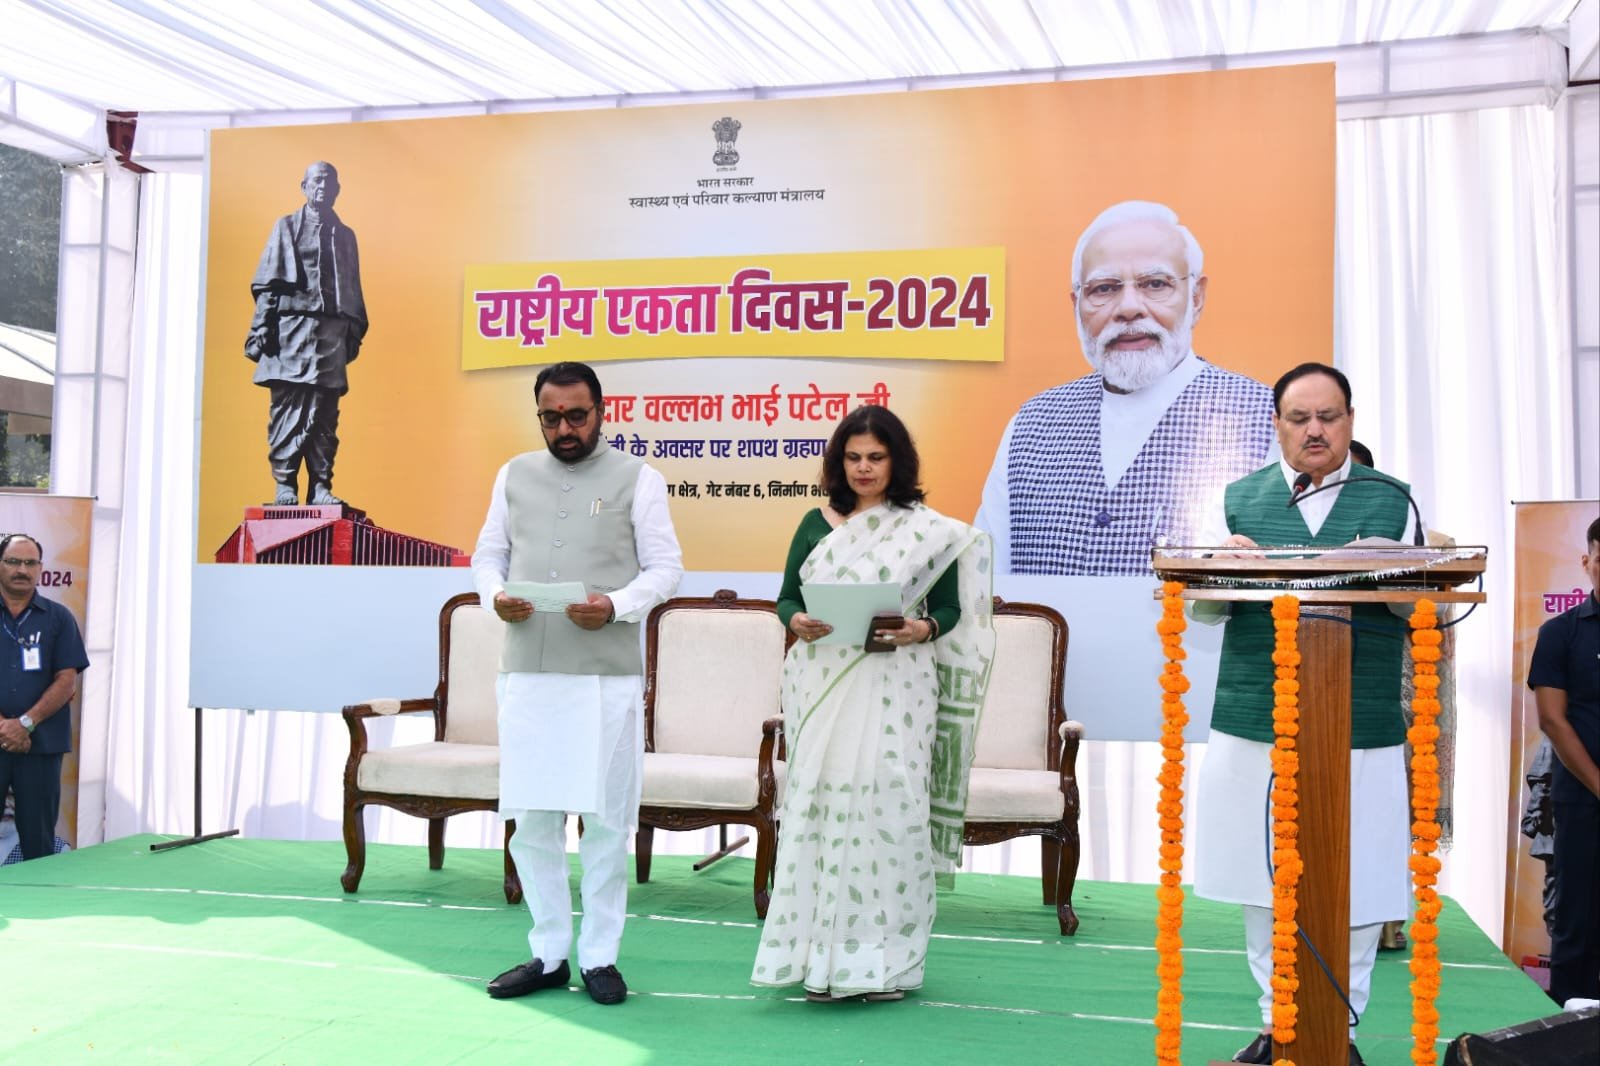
0, 493, 94, 860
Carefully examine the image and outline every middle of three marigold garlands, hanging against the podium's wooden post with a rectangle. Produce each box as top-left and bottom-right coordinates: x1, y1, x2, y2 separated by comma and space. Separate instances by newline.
1272, 595, 1302, 1066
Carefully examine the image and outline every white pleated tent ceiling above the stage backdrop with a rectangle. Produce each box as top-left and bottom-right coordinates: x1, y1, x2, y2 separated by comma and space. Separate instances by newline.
0, 0, 1597, 163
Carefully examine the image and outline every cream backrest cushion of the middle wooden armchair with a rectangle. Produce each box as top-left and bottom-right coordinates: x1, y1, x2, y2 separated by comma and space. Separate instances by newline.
645, 608, 784, 755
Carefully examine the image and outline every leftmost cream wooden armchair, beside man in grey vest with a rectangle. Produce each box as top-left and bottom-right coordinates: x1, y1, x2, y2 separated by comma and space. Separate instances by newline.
339, 592, 522, 903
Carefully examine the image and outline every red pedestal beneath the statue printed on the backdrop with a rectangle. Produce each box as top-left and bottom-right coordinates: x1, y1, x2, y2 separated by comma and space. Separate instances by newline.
216, 504, 472, 567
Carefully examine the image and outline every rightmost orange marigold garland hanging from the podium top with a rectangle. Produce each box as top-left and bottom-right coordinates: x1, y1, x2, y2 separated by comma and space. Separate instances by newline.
1406, 599, 1443, 1066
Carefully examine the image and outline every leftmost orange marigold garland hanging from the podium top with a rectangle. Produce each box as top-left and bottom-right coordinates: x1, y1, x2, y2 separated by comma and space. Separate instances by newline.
1155, 581, 1189, 1066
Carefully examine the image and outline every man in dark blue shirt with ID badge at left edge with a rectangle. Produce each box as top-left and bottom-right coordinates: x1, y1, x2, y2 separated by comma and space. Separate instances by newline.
0, 533, 90, 860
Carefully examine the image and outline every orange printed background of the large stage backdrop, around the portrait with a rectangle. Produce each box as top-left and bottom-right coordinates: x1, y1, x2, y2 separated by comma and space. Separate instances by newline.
197, 66, 1334, 571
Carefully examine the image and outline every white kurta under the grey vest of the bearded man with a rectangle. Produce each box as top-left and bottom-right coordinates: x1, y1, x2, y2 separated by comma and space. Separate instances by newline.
472, 466, 683, 813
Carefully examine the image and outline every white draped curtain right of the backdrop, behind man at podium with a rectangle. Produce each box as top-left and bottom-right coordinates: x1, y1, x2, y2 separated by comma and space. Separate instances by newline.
1334, 99, 1576, 936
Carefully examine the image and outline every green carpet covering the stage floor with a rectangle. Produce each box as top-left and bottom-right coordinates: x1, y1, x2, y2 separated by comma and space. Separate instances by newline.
0, 837, 1554, 1066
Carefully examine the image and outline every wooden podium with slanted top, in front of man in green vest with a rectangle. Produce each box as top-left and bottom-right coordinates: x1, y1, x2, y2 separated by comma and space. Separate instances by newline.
1152, 546, 1488, 1066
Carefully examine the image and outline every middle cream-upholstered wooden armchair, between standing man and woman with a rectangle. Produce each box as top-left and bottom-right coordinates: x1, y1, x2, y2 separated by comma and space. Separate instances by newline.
634, 589, 789, 917
